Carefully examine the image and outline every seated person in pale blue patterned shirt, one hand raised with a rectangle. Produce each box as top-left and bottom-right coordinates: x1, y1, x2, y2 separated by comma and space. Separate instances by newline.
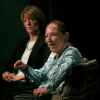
14, 20, 81, 100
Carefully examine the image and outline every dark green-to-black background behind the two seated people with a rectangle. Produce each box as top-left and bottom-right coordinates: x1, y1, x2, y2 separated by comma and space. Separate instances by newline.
0, 0, 99, 70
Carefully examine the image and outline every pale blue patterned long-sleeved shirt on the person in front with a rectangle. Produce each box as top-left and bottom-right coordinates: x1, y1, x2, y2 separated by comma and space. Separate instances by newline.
23, 46, 81, 92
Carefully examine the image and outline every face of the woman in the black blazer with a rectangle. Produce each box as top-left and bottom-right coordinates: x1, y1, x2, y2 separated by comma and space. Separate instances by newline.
24, 15, 39, 34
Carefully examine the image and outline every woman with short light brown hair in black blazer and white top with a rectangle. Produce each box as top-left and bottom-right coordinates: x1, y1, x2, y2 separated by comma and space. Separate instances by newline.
2, 6, 50, 100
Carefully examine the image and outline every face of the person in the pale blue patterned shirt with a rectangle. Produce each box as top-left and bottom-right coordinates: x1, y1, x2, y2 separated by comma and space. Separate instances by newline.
45, 23, 65, 53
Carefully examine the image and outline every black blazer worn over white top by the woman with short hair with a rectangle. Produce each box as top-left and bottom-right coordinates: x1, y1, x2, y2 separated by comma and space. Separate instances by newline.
5, 36, 50, 71
